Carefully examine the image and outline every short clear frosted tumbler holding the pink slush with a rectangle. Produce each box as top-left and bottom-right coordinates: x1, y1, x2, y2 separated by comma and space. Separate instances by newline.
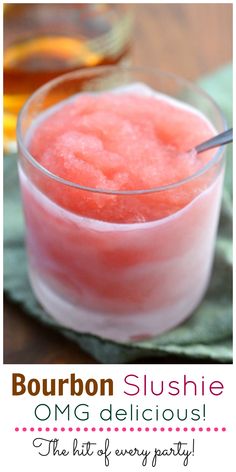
17, 66, 226, 341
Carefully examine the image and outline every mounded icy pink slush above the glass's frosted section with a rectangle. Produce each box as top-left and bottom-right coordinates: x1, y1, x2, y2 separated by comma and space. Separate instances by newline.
30, 85, 214, 223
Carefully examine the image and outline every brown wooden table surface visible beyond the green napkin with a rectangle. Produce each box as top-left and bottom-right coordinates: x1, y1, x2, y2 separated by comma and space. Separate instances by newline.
4, 3, 232, 364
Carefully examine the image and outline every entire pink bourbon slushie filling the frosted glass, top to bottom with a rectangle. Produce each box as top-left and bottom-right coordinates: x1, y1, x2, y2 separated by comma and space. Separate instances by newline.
20, 85, 222, 341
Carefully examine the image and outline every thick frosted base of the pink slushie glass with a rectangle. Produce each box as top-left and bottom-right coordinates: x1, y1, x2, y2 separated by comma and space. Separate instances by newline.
29, 270, 205, 342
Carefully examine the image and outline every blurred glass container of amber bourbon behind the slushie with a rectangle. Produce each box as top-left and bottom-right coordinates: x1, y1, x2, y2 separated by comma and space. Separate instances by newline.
4, 3, 132, 152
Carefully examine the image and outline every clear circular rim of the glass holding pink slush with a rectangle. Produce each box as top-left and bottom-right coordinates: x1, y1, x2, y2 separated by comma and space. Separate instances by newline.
16, 65, 227, 195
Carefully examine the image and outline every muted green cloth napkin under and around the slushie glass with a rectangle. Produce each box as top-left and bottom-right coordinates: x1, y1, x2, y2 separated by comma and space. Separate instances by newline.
4, 65, 232, 363
